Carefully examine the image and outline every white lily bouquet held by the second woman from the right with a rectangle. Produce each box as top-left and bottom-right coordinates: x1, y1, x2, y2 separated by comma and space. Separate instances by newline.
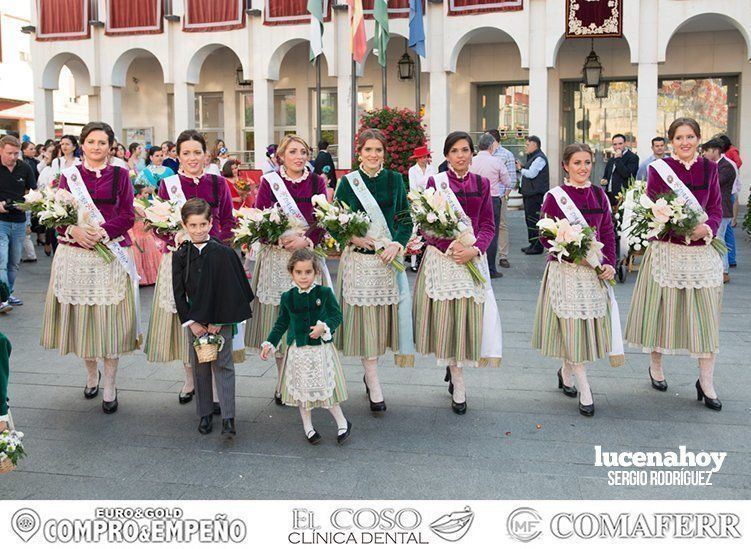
537, 217, 615, 286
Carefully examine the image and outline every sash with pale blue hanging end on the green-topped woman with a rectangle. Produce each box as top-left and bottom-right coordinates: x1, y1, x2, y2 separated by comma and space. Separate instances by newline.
345, 171, 415, 365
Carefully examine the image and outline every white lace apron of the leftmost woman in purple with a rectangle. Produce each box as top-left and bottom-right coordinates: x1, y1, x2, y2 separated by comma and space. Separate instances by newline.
53, 245, 129, 305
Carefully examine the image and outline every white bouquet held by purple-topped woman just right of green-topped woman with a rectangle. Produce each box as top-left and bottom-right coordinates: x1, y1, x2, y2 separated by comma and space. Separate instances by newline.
407, 187, 486, 284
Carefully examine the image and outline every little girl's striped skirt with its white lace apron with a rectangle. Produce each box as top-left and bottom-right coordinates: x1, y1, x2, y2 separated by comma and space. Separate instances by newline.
281, 343, 347, 410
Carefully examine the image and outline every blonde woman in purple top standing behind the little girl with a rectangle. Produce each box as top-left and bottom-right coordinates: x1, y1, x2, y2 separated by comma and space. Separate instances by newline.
245, 135, 329, 406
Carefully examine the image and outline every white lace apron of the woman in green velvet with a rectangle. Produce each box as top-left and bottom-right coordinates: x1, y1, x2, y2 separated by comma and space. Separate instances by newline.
339, 246, 399, 307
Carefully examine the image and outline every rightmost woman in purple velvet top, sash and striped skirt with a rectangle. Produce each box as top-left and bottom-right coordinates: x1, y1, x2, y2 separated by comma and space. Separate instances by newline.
626, 118, 722, 410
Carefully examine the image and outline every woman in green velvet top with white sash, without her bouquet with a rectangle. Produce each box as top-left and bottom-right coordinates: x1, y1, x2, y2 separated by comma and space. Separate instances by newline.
334, 129, 414, 412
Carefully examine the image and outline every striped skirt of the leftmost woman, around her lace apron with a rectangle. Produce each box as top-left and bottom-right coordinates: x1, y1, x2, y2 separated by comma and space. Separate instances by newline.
40, 244, 139, 360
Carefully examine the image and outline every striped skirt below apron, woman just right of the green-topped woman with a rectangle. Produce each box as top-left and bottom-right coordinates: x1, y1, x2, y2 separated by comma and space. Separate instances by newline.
412, 251, 483, 366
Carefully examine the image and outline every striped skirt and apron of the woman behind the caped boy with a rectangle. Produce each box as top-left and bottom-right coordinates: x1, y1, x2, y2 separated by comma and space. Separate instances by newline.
144, 253, 192, 364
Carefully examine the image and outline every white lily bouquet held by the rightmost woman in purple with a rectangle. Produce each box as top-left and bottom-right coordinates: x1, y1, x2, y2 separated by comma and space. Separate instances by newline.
633, 192, 728, 254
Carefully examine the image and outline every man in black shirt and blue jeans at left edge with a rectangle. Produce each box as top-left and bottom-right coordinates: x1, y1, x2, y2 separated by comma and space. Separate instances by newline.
0, 135, 37, 313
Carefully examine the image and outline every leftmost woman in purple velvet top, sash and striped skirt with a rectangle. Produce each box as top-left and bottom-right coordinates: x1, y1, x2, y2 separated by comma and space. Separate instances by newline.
41, 122, 139, 413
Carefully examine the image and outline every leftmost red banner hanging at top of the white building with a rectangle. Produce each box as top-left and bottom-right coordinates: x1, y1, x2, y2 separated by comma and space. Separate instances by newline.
36, 0, 91, 41
